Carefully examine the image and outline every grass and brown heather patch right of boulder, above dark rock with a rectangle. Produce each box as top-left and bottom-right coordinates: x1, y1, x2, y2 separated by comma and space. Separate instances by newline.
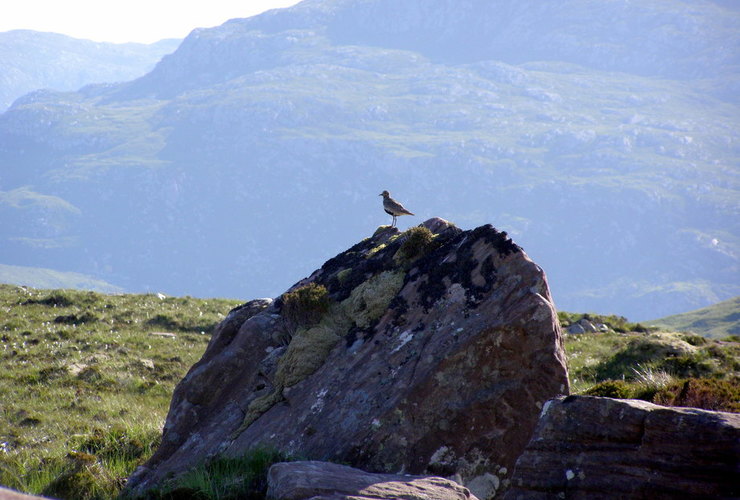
565, 324, 740, 412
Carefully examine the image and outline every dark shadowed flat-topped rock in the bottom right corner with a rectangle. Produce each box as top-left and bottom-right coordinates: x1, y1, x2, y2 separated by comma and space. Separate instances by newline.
505, 396, 740, 500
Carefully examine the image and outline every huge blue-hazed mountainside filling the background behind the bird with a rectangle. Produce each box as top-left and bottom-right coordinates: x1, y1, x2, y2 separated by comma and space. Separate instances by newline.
0, 0, 740, 321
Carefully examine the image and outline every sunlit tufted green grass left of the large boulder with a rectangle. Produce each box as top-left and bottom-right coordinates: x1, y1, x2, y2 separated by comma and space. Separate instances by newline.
0, 285, 239, 500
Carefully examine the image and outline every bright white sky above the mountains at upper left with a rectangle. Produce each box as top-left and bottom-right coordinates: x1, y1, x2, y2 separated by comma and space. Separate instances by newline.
0, 0, 298, 43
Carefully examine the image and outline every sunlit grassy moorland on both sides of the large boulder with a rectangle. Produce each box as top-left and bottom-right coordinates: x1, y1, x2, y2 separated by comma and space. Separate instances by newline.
0, 285, 740, 500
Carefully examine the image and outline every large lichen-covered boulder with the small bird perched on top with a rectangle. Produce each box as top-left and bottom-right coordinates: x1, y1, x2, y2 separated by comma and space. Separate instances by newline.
129, 219, 568, 496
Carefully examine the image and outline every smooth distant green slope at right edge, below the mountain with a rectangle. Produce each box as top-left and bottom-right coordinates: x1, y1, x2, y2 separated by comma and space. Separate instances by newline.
646, 297, 740, 338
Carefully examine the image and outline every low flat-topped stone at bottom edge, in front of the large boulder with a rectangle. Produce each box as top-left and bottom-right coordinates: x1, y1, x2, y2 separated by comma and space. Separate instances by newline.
267, 461, 477, 500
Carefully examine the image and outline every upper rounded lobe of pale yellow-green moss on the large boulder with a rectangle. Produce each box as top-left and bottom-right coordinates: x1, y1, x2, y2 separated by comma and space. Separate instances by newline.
340, 270, 405, 328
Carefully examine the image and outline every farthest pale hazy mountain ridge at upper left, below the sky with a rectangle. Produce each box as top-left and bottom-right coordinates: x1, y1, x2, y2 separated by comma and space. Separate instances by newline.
0, 30, 180, 111
